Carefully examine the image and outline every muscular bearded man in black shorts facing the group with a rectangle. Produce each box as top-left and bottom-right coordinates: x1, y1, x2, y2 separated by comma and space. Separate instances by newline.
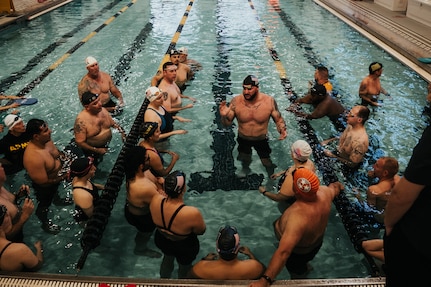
220, 75, 287, 180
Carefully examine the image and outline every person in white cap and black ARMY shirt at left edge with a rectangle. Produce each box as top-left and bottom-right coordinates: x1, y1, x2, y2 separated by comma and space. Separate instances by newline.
0, 114, 30, 175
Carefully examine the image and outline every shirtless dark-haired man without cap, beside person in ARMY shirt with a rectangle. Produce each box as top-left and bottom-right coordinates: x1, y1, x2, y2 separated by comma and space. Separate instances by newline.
23, 119, 73, 234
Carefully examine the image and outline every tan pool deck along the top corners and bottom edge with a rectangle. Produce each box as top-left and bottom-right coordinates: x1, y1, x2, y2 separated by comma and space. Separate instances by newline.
0, 0, 431, 287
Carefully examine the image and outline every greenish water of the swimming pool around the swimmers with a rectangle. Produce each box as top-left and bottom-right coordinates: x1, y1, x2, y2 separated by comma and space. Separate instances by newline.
0, 0, 427, 279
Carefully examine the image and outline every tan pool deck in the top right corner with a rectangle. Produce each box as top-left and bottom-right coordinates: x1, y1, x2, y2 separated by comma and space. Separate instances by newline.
314, 0, 431, 82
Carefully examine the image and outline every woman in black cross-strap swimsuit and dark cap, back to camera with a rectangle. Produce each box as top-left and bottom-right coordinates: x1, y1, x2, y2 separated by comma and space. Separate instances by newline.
150, 171, 206, 278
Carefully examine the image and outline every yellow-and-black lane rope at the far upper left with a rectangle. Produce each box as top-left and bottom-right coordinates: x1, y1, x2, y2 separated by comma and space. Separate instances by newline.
13, 0, 137, 97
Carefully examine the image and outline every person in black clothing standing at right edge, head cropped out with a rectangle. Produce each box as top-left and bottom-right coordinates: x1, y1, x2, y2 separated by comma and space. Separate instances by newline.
383, 126, 431, 287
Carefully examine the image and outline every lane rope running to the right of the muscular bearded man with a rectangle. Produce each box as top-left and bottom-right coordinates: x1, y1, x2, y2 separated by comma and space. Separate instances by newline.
248, 0, 379, 276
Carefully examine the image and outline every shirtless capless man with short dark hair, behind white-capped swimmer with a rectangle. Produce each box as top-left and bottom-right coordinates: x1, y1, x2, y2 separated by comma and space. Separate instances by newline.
158, 62, 196, 115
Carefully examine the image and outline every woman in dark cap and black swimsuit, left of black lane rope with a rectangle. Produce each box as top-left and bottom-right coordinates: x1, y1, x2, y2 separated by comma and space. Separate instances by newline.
70, 157, 105, 222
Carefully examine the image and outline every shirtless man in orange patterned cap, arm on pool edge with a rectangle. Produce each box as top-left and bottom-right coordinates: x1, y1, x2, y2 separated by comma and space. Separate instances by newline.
249, 168, 344, 287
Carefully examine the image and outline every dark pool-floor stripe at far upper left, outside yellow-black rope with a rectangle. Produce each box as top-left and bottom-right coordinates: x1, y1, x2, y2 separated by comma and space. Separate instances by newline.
0, 0, 121, 93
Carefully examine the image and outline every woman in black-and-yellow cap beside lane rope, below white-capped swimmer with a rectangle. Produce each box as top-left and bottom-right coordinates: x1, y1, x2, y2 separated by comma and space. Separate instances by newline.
139, 122, 179, 177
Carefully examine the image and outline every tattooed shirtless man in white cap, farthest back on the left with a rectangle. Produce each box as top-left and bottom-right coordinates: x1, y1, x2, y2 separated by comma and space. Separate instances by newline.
78, 57, 124, 113
